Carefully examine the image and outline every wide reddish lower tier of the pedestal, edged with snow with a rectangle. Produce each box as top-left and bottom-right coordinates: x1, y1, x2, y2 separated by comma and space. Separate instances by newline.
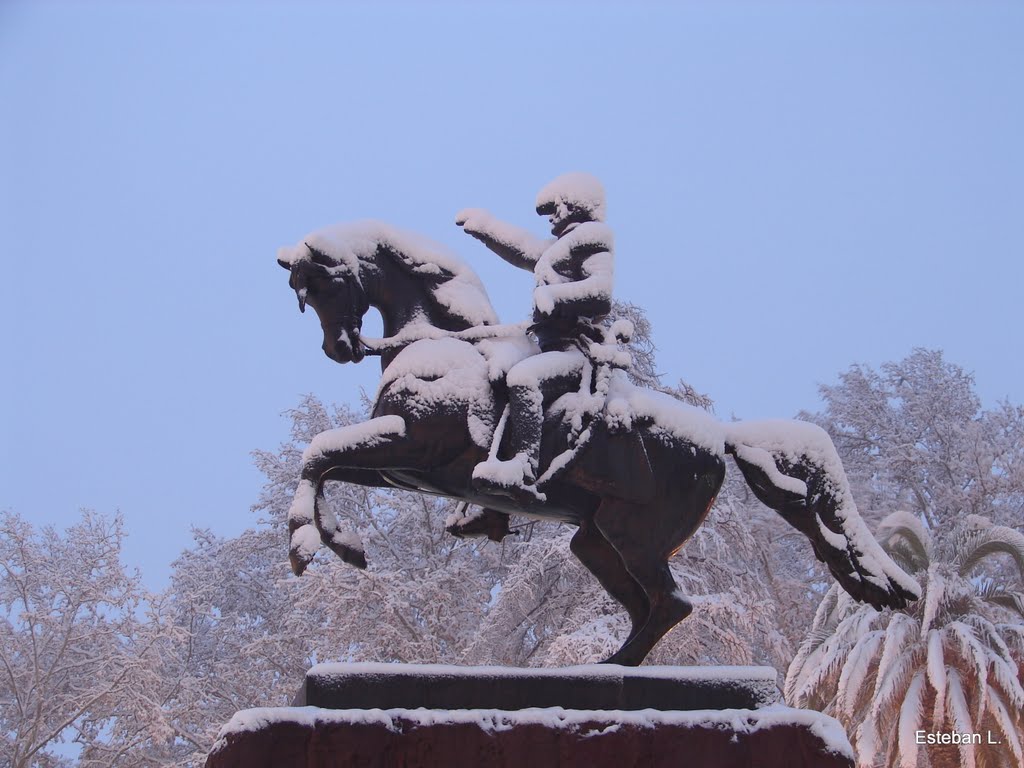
206, 706, 853, 768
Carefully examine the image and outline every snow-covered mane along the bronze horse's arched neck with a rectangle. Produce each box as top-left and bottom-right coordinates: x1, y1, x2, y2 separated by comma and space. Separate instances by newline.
288, 221, 498, 328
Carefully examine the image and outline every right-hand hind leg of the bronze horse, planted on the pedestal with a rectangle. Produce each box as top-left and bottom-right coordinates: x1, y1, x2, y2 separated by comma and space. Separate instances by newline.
594, 499, 693, 667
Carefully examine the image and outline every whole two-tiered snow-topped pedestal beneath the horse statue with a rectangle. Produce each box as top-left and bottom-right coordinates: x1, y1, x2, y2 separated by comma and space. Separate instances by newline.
207, 665, 853, 768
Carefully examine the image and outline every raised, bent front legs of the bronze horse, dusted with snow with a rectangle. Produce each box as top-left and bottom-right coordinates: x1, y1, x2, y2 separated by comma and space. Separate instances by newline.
288, 416, 408, 575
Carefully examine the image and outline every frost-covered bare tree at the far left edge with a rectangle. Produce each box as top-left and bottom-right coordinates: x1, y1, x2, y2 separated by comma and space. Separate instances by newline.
0, 512, 180, 768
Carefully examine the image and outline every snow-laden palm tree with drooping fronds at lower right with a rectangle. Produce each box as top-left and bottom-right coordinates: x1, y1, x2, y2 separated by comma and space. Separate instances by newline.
785, 512, 1024, 768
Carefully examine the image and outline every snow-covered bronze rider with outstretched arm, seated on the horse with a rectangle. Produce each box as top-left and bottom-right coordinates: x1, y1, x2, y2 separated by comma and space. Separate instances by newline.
456, 173, 612, 502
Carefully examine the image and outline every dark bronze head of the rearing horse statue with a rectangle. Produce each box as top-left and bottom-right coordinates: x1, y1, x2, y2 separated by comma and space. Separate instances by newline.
278, 243, 370, 362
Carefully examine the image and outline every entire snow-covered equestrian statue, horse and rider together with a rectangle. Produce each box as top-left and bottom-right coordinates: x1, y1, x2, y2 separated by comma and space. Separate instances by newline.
278, 174, 920, 665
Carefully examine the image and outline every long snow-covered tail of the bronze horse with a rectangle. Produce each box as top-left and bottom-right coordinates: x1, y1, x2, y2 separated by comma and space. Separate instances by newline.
725, 421, 921, 610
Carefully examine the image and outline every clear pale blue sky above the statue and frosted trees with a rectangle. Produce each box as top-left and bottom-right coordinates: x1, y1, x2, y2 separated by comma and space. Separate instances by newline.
0, 1, 1024, 586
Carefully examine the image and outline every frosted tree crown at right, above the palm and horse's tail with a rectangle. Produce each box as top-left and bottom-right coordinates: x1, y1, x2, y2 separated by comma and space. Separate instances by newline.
802, 349, 1024, 527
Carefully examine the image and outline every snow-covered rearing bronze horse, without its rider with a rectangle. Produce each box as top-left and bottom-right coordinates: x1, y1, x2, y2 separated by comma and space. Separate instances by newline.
279, 222, 920, 666
